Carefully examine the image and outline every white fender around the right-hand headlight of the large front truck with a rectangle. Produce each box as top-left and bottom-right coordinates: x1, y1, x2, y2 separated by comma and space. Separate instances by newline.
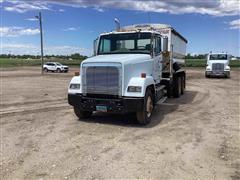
124, 76, 155, 97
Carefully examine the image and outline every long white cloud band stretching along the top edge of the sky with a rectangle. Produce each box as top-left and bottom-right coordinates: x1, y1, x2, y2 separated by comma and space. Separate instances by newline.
4, 0, 240, 16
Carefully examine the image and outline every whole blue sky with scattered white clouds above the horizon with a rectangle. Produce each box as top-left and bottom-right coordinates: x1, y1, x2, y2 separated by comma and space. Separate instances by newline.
0, 0, 240, 56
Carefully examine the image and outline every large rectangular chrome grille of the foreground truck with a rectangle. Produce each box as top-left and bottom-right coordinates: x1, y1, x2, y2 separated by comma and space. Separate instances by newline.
82, 65, 121, 95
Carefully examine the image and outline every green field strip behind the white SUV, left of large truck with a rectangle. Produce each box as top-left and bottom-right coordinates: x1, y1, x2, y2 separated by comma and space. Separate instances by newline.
0, 58, 82, 67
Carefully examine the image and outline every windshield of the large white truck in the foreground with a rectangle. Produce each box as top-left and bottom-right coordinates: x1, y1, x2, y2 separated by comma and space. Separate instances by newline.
98, 33, 151, 54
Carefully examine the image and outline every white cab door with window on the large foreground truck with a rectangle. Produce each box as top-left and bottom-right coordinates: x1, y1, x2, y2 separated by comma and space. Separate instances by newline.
153, 36, 162, 83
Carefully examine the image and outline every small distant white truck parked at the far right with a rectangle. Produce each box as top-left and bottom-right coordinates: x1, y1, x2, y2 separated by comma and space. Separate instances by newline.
205, 53, 230, 78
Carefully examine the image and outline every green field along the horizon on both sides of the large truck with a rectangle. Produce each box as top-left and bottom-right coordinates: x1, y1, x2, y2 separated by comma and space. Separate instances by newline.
0, 58, 240, 68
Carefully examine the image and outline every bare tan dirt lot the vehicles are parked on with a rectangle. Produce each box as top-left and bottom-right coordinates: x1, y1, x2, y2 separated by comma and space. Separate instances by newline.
0, 68, 240, 180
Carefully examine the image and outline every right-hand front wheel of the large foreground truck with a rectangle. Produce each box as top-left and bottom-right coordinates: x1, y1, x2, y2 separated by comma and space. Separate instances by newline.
136, 89, 154, 125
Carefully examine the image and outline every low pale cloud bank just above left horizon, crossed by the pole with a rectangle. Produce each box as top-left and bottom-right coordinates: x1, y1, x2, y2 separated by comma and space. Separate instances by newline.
2, 43, 92, 56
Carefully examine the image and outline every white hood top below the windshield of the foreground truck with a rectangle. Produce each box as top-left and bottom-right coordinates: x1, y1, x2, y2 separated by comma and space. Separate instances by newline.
83, 54, 151, 64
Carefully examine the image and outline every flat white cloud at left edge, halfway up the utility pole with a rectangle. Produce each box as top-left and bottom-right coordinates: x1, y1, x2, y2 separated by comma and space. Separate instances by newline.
0, 26, 39, 37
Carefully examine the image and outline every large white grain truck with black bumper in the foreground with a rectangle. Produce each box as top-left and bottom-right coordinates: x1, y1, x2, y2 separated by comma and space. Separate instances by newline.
68, 24, 187, 124
